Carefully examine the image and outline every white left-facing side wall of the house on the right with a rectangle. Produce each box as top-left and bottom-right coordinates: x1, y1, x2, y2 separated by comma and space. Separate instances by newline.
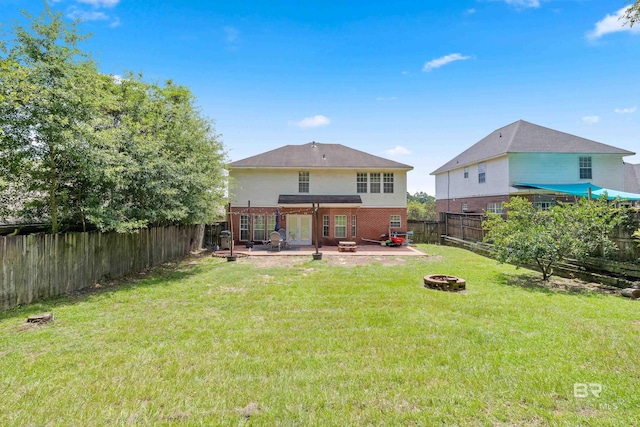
436, 156, 509, 200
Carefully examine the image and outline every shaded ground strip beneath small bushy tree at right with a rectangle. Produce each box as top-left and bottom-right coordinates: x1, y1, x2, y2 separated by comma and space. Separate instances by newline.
498, 274, 620, 296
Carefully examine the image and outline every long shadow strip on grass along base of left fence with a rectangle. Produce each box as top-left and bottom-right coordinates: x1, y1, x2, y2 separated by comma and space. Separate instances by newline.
0, 252, 226, 320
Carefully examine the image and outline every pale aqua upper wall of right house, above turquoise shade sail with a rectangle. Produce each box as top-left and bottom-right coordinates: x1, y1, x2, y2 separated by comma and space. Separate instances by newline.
509, 153, 624, 190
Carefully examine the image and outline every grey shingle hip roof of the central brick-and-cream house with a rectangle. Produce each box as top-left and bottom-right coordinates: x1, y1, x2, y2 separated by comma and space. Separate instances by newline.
229, 142, 413, 170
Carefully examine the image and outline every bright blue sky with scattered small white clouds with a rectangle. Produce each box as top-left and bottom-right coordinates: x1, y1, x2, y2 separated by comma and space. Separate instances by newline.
0, 0, 640, 194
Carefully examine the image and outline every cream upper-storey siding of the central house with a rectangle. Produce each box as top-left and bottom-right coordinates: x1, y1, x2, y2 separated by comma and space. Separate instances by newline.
229, 169, 407, 207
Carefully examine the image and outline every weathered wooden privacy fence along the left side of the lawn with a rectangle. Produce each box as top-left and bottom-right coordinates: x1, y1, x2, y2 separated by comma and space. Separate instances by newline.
0, 225, 204, 309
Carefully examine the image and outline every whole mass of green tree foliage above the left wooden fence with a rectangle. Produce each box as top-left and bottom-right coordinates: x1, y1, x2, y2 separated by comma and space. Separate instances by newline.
0, 3, 226, 233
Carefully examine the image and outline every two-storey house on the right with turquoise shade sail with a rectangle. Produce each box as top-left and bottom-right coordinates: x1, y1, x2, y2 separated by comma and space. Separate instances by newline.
431, 120, 640, 213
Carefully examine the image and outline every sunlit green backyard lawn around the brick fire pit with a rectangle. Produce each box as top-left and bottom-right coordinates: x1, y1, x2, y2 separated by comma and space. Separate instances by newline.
0, 245, 640, 426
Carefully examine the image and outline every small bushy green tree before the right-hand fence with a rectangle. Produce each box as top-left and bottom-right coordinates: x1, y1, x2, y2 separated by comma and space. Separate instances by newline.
484, 197, 624, 280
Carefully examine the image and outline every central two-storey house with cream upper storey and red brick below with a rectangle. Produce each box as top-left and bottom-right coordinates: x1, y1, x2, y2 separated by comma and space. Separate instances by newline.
229, 142, 413, 246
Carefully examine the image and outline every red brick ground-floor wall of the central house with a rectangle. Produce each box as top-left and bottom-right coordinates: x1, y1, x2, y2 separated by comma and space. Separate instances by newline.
226, 206, 407, 246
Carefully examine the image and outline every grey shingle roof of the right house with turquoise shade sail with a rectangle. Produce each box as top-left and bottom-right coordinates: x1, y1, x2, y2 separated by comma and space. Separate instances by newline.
431, 120, 635, 175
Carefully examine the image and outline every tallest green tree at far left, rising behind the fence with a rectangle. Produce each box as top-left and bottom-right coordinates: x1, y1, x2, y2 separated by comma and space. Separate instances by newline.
0, 4, 97, 233
